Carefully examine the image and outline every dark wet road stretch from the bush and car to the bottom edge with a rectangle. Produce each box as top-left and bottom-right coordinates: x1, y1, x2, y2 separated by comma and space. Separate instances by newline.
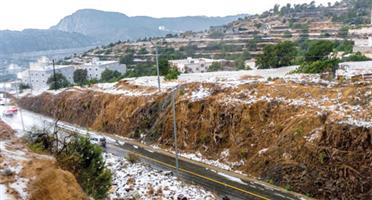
106, 143, 300, 199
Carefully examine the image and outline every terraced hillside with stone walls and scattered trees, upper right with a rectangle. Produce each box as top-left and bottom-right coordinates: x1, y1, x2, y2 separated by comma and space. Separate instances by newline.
64, 0, 372, 75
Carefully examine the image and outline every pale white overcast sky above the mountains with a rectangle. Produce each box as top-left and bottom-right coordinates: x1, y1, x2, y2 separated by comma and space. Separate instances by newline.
0, 0, 335, 30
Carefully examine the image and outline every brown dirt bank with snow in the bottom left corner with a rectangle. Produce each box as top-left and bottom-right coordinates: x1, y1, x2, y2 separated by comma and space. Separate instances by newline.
0, 120, 88, 200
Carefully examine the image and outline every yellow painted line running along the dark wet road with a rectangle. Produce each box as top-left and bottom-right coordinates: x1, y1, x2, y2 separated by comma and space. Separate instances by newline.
122, 146, 270, 200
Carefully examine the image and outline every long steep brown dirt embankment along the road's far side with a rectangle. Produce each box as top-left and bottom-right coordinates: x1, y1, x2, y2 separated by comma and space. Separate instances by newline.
20, 81, 372, 199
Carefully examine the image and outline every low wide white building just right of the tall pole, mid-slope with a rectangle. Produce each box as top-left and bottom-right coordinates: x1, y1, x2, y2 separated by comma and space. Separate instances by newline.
169, 57, 225, 73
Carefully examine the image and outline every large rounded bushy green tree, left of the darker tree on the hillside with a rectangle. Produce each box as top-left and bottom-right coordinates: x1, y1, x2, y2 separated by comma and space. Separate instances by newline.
256, 41, 297, 69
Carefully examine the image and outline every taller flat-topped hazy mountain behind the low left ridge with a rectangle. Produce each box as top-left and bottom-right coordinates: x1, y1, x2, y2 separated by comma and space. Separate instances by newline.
51, 9, 246, 42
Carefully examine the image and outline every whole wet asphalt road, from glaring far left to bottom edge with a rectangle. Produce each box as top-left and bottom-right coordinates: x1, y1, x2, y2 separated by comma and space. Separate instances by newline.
0, 107, 301, 200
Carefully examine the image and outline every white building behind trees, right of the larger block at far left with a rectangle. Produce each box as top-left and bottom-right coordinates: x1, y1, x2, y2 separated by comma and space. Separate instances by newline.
76, 58, 127, 80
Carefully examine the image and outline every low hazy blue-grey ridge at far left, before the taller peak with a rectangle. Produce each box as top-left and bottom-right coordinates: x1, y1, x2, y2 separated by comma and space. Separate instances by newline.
0, 29, 95, 54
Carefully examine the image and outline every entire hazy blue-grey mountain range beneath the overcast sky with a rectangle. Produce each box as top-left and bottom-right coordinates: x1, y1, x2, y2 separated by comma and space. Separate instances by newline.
0, 9, 244, 54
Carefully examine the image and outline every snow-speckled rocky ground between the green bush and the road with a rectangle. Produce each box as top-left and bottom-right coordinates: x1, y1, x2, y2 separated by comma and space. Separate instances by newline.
105, 154, 216, 200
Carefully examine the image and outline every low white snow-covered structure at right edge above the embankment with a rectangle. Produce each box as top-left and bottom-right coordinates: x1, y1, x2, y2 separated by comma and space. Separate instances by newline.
336, 61, 372, 81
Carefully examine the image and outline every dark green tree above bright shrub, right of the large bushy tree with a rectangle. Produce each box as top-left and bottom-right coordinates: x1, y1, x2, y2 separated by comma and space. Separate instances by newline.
305, 40, 335, 62
